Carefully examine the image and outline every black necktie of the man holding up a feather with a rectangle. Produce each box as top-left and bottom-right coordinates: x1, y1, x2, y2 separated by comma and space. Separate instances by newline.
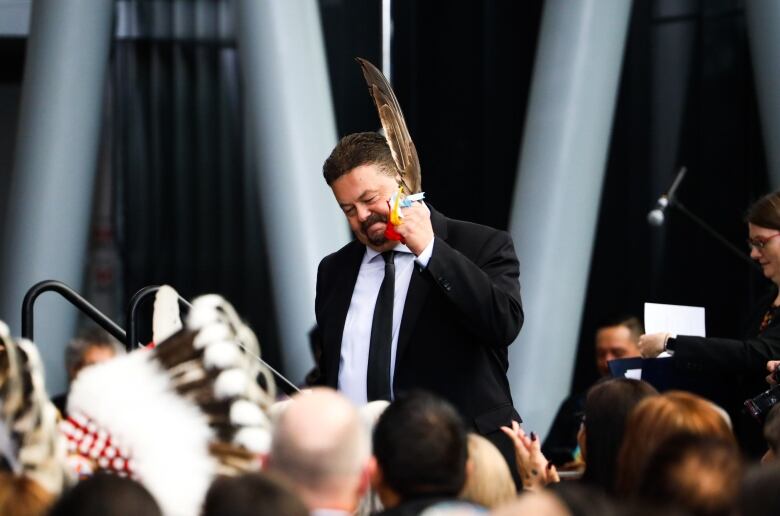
366, 251, 395, 401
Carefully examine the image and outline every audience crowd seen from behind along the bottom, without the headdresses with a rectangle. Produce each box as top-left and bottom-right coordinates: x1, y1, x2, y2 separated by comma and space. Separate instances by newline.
0, 364, 780, 516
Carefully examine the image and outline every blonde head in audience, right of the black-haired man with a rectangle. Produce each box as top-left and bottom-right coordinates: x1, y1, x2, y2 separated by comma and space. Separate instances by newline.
460, 433, 517, 509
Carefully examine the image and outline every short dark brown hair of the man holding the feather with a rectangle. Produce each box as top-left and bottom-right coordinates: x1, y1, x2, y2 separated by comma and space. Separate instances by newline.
322, 133, 397, 186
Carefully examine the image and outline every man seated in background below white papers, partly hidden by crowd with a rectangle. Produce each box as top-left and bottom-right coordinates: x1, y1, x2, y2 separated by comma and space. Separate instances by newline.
542, 315, 644, 468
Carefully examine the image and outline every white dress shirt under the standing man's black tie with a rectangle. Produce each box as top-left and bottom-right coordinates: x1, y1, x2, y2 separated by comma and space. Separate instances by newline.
338, 239, 434, 406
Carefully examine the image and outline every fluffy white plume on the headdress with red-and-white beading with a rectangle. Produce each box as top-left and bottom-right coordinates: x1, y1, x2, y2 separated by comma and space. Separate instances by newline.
68, 350, 217, 516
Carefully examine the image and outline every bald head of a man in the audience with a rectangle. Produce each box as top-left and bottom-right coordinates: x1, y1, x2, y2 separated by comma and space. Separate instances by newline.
268, 388, 371, 511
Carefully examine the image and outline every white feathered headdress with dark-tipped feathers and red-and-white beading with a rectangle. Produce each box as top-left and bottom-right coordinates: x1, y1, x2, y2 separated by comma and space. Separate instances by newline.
63, 295, 275, 515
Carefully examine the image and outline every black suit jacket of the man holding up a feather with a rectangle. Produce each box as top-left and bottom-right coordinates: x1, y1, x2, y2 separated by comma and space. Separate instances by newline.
315, 206, 523, 434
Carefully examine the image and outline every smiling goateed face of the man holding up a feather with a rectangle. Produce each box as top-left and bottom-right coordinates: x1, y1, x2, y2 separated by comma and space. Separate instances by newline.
331, 164, 398, 252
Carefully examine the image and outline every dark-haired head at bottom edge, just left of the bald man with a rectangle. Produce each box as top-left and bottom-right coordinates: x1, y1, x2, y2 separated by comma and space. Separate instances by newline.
202, 473, 309, 516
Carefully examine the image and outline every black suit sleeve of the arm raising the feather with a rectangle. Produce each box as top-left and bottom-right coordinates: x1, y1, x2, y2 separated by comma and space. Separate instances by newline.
427, 230, 523, 347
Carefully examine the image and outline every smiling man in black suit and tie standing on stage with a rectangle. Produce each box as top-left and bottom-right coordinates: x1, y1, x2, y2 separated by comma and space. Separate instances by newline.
315, 133, 523, 473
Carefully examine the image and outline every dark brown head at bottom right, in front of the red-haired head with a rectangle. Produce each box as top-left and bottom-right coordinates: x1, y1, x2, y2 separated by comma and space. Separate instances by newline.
637, 433, 743, 516
